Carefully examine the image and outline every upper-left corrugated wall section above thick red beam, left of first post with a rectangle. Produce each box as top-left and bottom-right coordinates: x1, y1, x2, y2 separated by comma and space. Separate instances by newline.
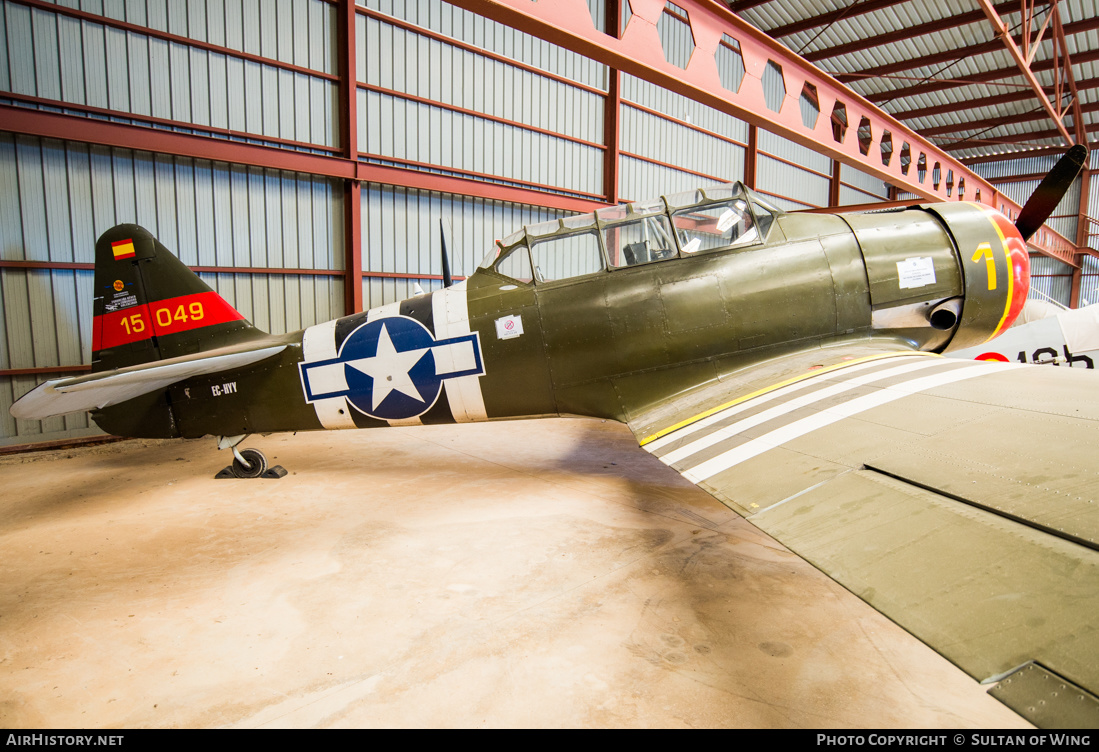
0, 0, 337, 146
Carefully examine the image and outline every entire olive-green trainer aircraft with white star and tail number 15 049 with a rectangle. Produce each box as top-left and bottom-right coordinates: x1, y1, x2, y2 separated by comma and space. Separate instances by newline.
11, 146, 1099, 728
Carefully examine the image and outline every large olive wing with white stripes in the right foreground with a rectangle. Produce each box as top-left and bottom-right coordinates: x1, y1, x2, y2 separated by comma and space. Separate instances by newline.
630, 345, 1099, 728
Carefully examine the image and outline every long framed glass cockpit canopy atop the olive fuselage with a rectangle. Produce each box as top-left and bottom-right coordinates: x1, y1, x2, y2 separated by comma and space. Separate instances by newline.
480, 183, 780, 283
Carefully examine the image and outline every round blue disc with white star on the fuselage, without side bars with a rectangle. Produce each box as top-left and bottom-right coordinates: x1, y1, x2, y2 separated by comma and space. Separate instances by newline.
338, 316, 442, 420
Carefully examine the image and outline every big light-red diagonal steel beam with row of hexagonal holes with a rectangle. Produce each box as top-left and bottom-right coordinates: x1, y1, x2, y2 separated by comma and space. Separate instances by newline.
443, 0, 1075, 259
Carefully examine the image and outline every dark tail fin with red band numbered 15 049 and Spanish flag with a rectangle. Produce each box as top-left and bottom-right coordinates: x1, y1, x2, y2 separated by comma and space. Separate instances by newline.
91, 224, 265, 372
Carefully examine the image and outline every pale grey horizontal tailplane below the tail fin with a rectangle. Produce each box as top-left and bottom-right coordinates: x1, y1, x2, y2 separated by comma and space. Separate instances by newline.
9, 341, 286, 420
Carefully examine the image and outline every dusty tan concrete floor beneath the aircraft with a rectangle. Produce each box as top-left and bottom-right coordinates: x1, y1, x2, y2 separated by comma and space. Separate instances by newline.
0, 420, 1026, 728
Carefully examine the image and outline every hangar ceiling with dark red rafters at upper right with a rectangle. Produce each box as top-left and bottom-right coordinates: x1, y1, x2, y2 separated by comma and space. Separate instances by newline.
728, 0, 1099, 162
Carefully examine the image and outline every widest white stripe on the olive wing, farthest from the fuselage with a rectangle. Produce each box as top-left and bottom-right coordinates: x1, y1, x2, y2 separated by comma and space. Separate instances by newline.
680, 364, 1022, 483
